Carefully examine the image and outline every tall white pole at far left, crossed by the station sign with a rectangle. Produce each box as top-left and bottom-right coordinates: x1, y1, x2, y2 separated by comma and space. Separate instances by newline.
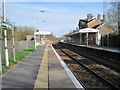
2, 0, 9, 66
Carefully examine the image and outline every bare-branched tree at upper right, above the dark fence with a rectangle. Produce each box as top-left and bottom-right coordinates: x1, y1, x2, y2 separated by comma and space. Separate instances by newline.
105, 2, 120, 34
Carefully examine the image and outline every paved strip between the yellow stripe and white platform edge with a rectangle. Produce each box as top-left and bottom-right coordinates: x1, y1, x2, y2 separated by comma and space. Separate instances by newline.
48, 46, 76, 90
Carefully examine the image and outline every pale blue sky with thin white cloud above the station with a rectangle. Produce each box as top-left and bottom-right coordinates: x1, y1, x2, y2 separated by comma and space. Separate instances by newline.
0, 2, 103, 37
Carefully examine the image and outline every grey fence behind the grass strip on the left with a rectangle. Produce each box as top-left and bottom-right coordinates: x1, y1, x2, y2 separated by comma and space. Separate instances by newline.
0, 41, 34, 58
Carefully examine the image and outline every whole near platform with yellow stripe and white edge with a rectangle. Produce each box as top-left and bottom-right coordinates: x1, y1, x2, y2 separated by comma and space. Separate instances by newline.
2, 44, 83, 90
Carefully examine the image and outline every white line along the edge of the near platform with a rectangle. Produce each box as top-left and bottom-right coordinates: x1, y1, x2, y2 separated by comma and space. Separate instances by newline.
51, 45, 84, 90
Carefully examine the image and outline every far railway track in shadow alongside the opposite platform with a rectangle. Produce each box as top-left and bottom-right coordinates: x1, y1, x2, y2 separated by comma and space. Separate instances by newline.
59, 43, 120, 73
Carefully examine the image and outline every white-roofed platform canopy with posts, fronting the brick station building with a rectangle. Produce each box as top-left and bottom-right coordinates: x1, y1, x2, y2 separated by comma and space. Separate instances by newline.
65, 28, 101, 45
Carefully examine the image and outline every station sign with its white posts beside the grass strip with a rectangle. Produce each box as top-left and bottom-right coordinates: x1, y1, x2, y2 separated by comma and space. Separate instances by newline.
0, 0, 16, 67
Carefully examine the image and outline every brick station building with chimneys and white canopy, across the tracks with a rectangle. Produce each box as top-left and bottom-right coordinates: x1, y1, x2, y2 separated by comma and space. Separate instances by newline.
64, 14, 113, 45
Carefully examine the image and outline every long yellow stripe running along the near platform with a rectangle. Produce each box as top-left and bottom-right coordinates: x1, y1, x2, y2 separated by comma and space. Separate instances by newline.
34, 45, 48, 90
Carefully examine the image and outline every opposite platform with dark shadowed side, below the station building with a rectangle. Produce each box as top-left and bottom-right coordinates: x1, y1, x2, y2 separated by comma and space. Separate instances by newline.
59, 42, 120, 63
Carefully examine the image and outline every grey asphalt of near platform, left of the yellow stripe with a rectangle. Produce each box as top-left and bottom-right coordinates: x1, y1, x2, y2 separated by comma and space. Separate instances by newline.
2, 46, 45, 90
